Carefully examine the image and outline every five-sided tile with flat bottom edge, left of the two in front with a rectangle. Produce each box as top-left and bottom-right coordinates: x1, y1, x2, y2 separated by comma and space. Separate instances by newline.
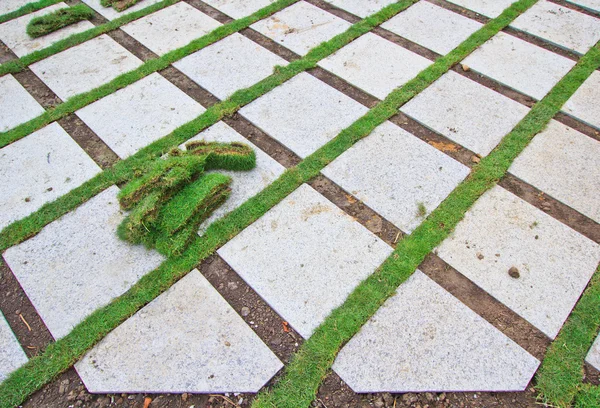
75, 269, 283, 393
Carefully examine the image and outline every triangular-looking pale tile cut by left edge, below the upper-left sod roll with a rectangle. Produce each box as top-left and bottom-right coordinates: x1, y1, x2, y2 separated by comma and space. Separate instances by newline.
0, 74, 45, 132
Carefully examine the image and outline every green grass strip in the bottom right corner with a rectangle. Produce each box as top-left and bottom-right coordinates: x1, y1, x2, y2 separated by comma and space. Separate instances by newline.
536, 267, 600, 407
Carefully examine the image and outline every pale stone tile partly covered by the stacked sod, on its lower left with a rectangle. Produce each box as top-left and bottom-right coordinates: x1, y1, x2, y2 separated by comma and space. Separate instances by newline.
4, 186, 163, 339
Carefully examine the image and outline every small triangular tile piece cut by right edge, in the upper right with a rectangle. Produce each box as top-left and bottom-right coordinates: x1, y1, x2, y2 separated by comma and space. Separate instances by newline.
563, 71, 600, 130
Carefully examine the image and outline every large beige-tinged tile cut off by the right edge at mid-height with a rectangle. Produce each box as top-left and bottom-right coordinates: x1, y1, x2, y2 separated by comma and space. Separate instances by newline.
509, 121, 600, 223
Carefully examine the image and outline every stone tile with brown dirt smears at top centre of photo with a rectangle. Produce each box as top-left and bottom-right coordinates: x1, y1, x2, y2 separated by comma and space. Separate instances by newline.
251, 1, 351, 55
